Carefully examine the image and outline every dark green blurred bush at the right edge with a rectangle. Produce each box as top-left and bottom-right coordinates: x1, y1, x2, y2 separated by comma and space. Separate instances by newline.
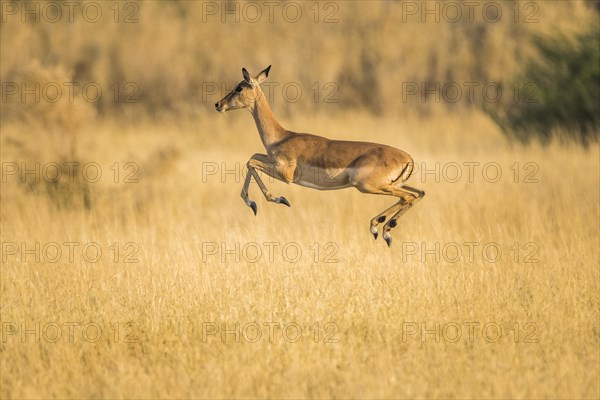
486, 25, 600, 145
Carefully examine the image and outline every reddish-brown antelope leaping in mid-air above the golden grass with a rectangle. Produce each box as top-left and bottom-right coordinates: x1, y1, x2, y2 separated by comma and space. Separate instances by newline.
215, 65, 425, 246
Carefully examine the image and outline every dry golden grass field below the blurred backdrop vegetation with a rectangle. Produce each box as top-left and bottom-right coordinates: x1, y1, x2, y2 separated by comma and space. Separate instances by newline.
0, 2, 600, 398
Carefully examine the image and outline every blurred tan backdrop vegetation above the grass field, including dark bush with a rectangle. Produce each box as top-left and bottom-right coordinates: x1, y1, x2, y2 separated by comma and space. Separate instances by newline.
0, 1, 600, 143
